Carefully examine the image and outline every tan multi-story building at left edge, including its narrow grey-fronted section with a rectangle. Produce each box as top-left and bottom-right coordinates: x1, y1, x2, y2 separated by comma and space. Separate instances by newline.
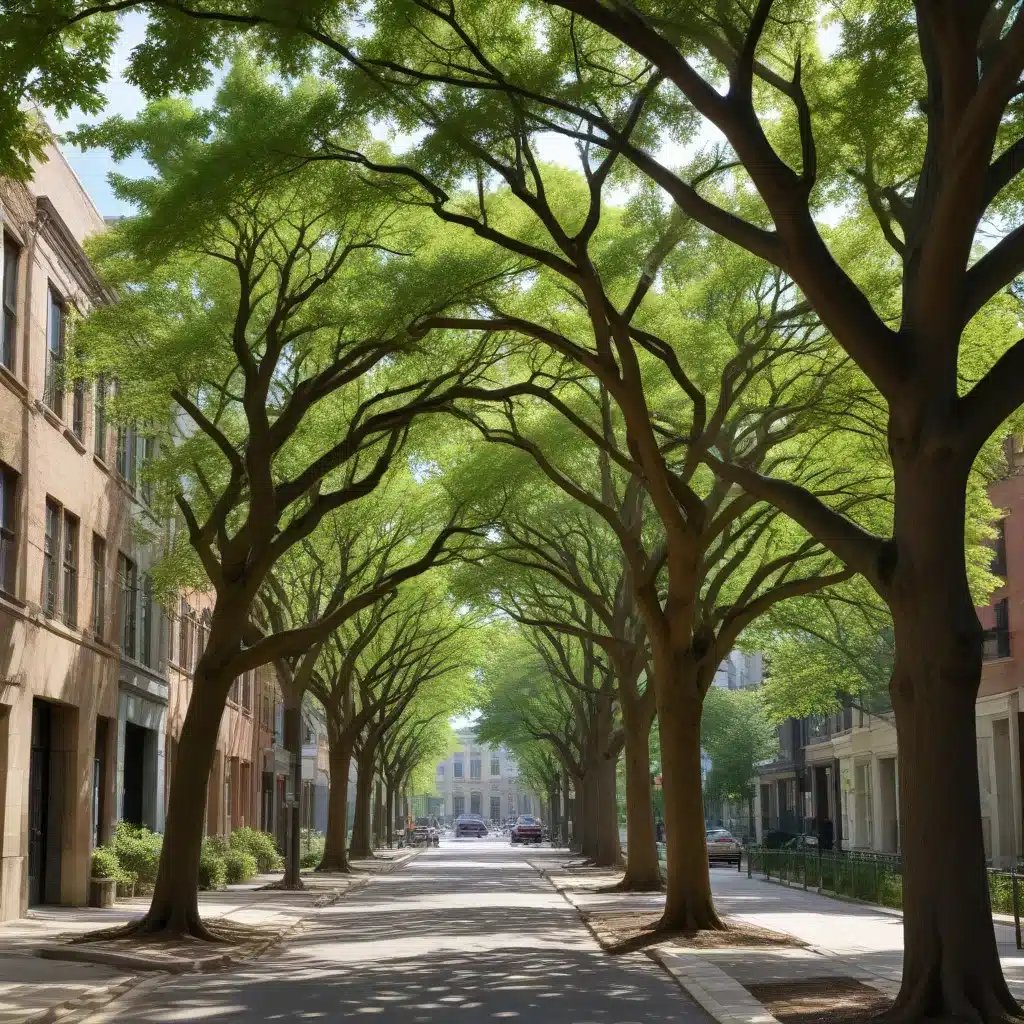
0, 146, 177, 918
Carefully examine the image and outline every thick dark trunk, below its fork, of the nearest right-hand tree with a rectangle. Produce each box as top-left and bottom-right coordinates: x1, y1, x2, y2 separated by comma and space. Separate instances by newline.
889, 453, 1022, 1022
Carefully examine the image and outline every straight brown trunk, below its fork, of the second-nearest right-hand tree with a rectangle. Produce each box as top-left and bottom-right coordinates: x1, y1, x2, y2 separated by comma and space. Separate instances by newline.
655, 666, 723, 932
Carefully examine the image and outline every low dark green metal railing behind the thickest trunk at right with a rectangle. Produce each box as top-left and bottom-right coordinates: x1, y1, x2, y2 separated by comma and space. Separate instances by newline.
743, 846, 1024, 949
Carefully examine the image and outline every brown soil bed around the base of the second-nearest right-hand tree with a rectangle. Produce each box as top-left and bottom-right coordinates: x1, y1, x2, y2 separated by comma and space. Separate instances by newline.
582, 910, 807, 953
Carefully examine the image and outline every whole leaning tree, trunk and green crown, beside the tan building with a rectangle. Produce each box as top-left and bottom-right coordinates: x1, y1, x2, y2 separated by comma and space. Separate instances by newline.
73, 62, 532, 937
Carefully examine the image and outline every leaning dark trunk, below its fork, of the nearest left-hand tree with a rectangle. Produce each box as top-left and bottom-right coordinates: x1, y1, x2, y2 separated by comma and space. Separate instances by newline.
129, 659, 233, 940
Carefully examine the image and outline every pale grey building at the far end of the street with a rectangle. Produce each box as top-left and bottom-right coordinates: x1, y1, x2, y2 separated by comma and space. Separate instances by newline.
427, 729, 542, 821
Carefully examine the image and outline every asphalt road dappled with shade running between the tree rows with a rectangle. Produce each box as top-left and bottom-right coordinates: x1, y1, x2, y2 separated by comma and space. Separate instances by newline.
81, 840, 711, 1024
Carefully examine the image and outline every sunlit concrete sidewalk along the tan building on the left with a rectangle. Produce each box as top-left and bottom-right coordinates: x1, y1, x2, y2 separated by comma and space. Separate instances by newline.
0, 850, 409, 1024
